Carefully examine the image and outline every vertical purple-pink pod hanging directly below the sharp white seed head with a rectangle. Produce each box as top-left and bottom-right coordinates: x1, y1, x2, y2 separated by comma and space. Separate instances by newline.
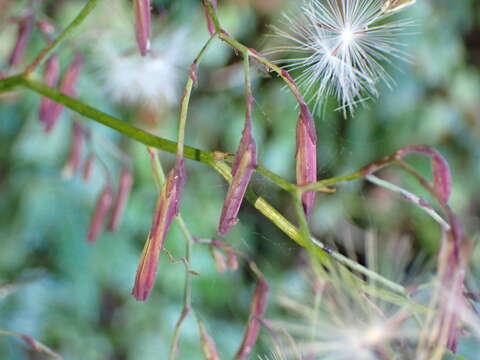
296, 104, 317, 216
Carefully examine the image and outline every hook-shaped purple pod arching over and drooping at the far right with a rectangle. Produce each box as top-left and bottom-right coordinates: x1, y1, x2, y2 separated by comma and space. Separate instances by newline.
396, 146, 452, 204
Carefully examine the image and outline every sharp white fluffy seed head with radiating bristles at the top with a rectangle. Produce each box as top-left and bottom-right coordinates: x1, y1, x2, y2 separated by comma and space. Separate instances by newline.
270, 0, 410, 113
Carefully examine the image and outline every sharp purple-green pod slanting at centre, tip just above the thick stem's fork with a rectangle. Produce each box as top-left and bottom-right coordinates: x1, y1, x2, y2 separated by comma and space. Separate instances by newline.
218, 115, 257, 235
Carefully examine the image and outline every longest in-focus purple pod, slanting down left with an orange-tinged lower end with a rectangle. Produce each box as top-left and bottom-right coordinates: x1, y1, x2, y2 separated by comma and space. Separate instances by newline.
132, 158, 186, 301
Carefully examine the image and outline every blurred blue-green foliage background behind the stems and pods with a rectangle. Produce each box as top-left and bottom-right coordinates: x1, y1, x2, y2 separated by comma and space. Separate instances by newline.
0, 0, 480, 360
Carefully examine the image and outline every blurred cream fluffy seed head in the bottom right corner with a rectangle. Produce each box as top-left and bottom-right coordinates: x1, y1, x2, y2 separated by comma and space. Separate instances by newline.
266, 229, 480, 360
